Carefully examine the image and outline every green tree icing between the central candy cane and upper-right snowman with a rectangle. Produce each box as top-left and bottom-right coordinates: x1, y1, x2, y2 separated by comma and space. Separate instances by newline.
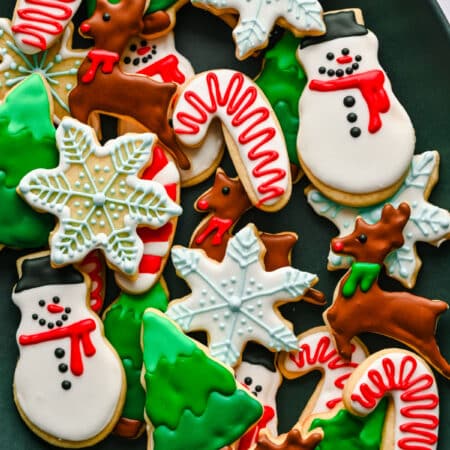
255, 31, 307, 165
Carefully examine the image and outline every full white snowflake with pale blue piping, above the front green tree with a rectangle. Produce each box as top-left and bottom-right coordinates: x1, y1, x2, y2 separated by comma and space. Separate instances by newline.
167, 225, 317, 366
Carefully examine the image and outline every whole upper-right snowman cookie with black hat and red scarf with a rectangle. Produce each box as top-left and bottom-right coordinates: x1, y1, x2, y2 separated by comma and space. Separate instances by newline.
297, 10, 415, 206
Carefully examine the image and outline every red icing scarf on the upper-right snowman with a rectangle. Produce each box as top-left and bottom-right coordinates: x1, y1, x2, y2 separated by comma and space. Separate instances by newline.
309, 70, 391, 133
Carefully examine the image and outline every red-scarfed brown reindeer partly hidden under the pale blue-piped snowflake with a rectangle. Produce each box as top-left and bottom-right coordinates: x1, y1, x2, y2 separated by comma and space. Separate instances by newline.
190, 168, 326, 305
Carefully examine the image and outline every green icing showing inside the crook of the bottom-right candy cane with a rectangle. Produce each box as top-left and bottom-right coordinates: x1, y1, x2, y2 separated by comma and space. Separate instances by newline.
310, 399, 388, 450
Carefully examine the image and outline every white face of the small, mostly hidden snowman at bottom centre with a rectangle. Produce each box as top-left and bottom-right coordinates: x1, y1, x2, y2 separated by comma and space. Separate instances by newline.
236, 362, 281, 405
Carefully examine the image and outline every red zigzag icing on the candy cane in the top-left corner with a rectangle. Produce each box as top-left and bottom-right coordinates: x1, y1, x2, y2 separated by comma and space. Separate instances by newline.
12, 0, 75, 51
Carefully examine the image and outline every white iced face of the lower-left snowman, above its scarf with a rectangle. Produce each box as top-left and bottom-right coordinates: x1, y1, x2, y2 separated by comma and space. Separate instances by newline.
13, 283, 87, 334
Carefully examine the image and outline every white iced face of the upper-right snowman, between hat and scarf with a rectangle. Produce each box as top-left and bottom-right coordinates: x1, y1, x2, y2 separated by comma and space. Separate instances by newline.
297, 31, 381, 81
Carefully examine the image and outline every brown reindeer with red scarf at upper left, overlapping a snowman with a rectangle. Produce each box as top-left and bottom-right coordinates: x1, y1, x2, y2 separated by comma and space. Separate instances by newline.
69, 0, 190, 169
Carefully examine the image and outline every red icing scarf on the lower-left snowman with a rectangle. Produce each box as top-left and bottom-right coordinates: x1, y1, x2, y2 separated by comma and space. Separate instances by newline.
19, 319, 96, 376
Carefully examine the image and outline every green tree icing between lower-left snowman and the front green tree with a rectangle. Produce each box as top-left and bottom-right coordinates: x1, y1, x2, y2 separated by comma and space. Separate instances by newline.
104, 283, 168, 421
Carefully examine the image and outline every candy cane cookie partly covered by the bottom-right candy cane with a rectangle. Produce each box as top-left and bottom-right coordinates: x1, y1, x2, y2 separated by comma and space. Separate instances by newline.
278, 327, 368, 426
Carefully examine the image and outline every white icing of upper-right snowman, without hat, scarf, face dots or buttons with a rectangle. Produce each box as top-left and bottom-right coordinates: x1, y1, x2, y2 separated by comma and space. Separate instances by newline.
297, 32, 415, 194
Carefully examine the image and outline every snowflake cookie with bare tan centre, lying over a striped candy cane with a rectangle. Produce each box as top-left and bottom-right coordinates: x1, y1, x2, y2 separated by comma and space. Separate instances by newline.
18, 117, 182, 276
